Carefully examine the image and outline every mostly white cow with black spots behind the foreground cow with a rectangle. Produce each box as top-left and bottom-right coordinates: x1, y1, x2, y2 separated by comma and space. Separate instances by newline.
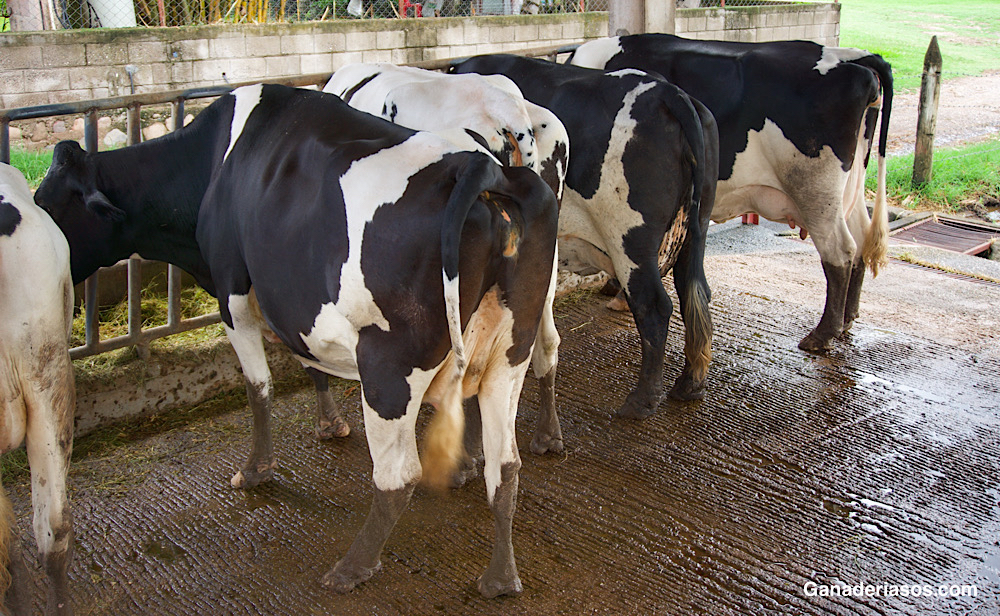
323, 63, 569, 454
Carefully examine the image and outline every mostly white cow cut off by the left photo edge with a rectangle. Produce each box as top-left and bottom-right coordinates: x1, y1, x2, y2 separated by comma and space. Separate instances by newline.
0, 163, 76, 616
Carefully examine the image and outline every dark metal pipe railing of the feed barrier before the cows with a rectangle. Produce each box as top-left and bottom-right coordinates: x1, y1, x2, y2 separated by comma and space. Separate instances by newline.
0, 45, 578, 359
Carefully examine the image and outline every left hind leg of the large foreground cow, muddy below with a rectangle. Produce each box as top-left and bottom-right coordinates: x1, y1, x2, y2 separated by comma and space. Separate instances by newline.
322, 384, 425, 593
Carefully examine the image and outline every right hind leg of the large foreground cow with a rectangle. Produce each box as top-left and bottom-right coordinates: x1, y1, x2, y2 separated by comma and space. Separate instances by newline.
478, 363, 527, 599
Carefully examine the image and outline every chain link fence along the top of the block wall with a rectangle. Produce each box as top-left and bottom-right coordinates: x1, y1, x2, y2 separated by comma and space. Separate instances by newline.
0, 0, 828, 32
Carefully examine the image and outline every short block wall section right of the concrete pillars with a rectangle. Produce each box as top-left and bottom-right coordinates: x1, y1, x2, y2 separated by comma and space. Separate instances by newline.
674, 2, 841, 45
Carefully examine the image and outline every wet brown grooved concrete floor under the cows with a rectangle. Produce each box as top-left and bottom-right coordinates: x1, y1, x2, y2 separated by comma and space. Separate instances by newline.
7, 220, 1000, 616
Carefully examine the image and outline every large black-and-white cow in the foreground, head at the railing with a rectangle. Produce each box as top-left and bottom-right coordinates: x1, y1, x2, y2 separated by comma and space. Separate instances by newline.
35, 85, 558, 596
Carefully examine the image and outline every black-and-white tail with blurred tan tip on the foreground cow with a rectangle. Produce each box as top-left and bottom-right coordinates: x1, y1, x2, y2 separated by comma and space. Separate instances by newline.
421, 155, 503, 488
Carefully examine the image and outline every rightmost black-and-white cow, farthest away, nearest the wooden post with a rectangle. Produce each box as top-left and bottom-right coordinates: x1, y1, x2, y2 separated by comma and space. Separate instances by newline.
571, 34, 892, 351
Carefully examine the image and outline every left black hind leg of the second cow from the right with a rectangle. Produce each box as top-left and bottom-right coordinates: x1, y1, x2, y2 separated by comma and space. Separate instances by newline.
618, 263, 673, 419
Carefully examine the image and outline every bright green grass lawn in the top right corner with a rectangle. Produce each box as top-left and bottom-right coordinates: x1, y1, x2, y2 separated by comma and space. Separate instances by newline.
840, 0, 1000, 91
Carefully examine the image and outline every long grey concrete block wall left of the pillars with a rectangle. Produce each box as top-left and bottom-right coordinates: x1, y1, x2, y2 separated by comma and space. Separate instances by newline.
0, 13, 608, 109
